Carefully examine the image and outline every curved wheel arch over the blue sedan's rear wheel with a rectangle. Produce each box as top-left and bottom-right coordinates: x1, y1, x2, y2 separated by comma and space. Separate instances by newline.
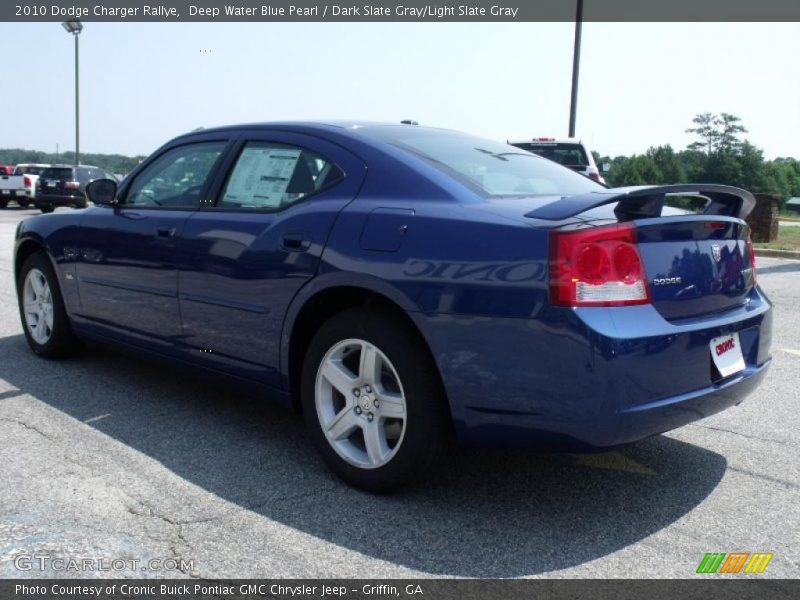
281, 276, 449, 412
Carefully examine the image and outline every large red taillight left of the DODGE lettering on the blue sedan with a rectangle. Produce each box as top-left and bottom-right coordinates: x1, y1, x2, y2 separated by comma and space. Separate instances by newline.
550, 223, 651, 306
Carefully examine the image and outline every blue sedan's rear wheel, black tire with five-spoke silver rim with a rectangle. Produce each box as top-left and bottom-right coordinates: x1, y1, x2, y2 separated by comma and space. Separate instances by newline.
300, 308, 450, 493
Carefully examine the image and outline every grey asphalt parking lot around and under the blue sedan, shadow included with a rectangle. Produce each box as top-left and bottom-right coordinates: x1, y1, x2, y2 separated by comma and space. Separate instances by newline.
0, 209, 800, 578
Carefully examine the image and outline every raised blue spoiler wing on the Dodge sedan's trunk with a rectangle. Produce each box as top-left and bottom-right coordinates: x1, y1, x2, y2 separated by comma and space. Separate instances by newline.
525, 183, 756, 221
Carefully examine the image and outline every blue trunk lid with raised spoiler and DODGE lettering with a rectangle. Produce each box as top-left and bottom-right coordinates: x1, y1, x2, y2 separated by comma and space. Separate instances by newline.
476, 184, 755, 320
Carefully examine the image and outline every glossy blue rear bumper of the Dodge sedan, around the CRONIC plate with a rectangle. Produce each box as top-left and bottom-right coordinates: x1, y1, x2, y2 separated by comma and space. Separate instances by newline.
414, 290, 772, 448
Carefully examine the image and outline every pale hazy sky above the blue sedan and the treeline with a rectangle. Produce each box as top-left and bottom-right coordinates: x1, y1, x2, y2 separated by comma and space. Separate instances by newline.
0, 22, 800, 158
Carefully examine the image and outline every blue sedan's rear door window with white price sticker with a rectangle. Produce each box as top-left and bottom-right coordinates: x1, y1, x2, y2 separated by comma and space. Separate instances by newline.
217, 142, 344, 210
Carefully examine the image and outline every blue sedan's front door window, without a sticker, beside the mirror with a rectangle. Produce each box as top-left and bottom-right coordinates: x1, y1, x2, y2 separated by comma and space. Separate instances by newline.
125, 142, 226, 208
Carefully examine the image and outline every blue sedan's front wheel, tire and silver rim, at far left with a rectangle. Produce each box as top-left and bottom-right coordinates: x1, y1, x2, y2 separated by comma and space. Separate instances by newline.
17, 252, 79, 358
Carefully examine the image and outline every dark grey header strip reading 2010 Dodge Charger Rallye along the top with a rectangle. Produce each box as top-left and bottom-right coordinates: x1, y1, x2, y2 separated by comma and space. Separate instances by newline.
0, 0, 800, 22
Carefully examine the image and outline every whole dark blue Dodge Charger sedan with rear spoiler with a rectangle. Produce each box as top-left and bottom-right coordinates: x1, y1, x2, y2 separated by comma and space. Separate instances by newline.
14, 123, 772, 491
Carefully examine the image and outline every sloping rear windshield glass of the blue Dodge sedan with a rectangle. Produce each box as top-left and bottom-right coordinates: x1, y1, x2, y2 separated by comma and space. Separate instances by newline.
363, 126, 604, 197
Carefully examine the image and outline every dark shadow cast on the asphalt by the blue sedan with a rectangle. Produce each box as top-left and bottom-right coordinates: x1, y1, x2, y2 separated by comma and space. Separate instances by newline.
0, 335, 727, 578
